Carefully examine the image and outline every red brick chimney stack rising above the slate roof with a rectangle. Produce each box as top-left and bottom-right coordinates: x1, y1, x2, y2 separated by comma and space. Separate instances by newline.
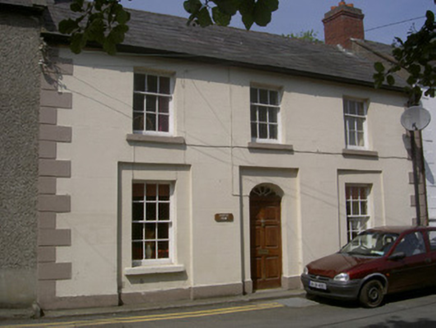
322, 1, 365, 49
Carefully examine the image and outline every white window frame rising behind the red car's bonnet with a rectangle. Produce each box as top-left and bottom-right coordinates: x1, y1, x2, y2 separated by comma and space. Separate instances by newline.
345, 184, 372, 241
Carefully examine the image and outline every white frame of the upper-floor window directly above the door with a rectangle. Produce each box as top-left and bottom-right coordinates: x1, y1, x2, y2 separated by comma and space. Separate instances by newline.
250, 86, 281, 143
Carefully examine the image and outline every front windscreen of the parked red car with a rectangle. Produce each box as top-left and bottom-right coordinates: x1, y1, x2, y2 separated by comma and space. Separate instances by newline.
340, 232, 398, 257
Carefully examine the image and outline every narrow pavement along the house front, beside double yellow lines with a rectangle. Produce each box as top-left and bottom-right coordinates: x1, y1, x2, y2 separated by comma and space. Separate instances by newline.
0, 289, 311, 326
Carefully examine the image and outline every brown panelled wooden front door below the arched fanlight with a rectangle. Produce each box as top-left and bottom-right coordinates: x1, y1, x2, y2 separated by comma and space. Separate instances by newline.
250, 194, 282, 290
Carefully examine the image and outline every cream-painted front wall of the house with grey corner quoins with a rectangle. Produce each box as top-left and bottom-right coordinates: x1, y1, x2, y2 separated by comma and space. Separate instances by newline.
52, 50, 414, 296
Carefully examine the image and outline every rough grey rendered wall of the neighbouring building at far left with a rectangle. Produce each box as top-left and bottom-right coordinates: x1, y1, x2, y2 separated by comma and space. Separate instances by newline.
0, 8, 40, 307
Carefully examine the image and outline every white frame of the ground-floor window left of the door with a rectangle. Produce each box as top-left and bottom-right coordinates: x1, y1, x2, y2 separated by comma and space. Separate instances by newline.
130, 181, 175, 267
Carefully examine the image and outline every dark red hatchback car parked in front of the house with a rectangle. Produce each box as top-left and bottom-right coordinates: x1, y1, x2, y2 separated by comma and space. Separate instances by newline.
301, 226, 436, 308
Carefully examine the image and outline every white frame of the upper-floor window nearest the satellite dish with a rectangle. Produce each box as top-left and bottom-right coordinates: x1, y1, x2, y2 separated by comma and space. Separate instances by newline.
343, 98, 368, 149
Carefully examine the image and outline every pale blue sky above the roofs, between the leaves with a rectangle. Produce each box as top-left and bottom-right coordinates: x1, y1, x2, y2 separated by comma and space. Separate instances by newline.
117, 0, 436, 44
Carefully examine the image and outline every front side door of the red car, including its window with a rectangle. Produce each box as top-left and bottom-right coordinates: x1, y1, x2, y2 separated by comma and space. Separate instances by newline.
387, 231, 432, 292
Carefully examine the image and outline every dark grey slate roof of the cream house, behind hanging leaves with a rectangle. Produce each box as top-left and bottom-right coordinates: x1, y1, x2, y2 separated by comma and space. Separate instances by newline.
41, 4, 406, 90
